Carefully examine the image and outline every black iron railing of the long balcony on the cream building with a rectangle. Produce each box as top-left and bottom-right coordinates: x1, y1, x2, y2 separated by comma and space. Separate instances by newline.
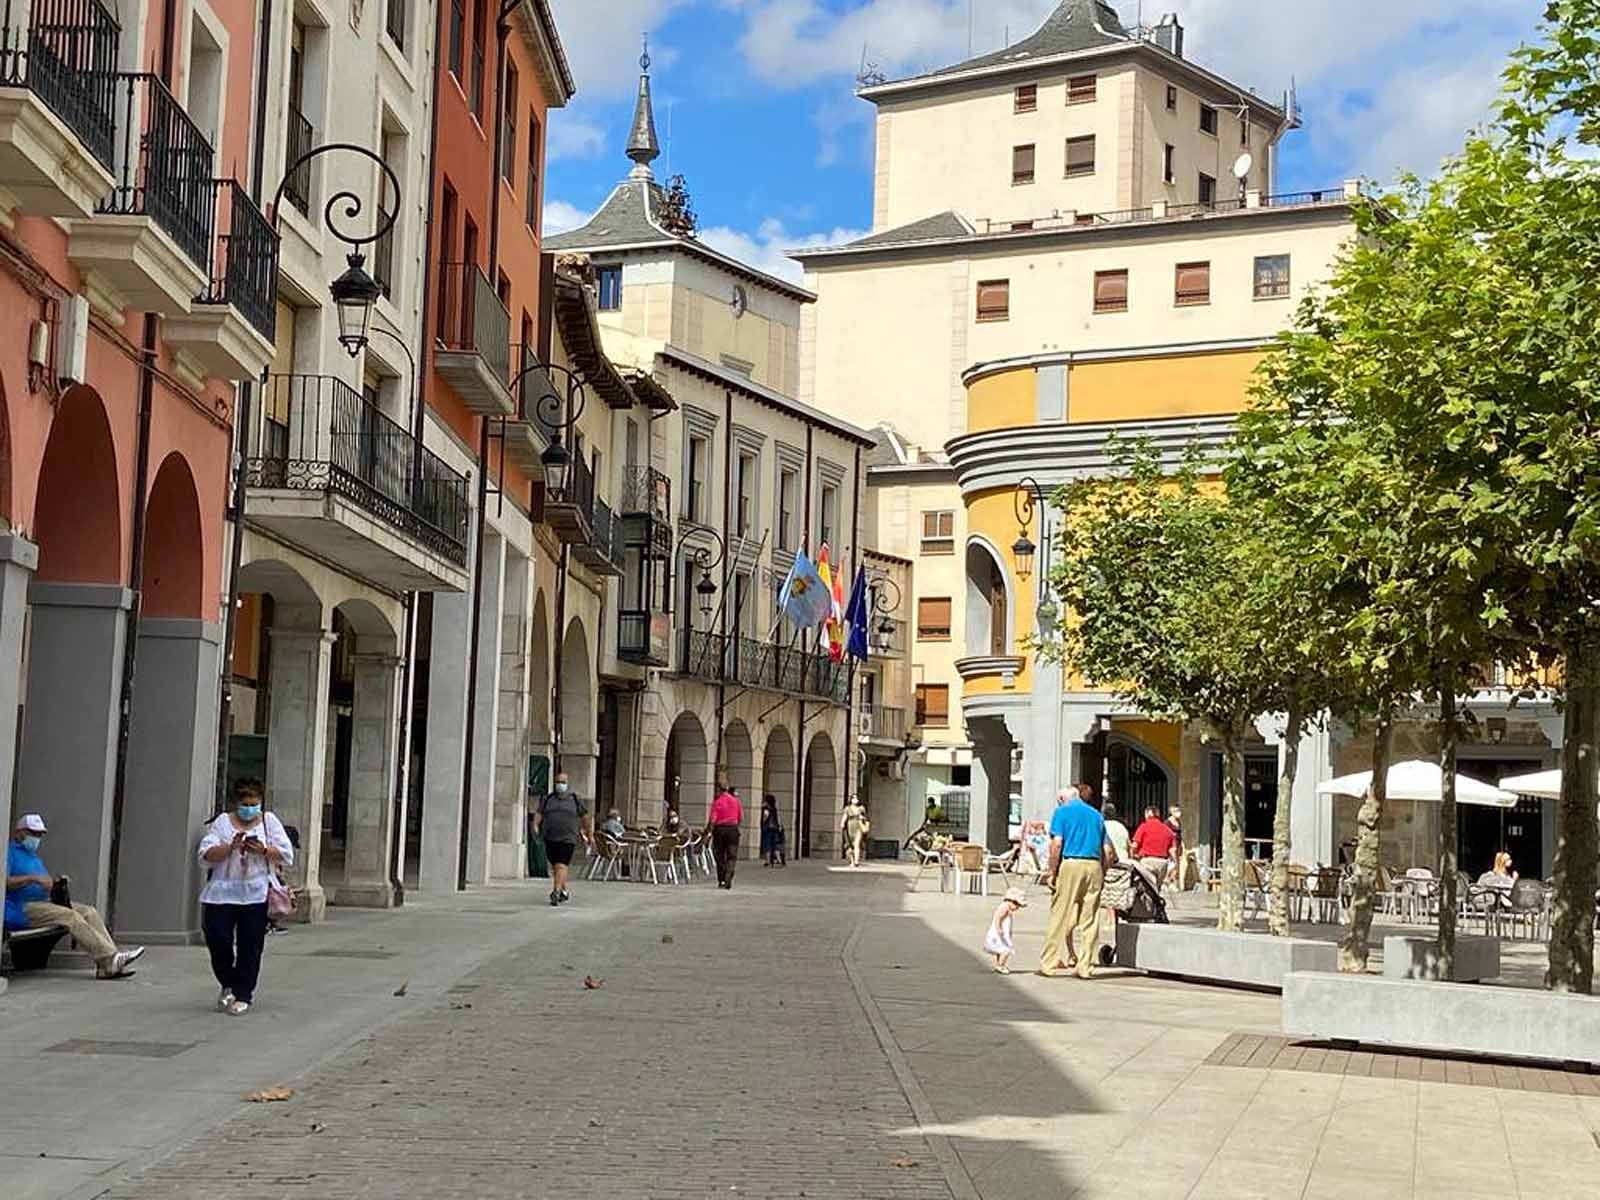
248, 374, 469, 566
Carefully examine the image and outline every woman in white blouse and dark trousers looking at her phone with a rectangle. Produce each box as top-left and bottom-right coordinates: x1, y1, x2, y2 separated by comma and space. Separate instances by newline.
200, 779, 294, 1016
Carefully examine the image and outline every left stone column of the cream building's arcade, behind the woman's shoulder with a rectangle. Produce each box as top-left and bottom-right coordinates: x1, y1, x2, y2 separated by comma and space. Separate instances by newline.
266, 627, 334, 922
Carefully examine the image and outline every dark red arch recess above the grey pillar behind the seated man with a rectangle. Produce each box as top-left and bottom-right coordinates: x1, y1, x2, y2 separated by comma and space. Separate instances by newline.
34, 386, 122, 584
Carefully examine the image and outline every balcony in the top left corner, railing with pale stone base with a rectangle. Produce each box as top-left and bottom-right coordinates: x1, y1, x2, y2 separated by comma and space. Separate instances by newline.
0, 0, 122, 218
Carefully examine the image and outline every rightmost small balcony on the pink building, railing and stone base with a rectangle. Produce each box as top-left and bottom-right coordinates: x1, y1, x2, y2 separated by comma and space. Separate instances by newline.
163, 179, 278, 379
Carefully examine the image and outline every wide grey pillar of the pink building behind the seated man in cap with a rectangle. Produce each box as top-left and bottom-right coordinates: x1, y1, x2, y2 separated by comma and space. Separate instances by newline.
14, 579, 133, 909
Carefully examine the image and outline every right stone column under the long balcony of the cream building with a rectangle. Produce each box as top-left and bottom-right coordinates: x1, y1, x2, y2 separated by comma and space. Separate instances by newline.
333, 654, 402, 909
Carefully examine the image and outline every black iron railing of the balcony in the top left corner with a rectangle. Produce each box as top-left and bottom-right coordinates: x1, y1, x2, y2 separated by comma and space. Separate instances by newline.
0, 0, 122, 171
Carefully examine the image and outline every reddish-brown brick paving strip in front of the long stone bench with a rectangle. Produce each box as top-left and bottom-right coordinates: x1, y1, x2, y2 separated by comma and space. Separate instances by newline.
1206, 1034, 1600, 1096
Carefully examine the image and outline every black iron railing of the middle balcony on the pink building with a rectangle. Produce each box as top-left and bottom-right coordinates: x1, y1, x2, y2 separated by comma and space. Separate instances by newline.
94, 72, 218, 272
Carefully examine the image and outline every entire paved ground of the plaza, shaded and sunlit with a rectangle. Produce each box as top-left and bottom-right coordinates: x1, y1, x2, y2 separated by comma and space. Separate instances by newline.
0, 864, 1600, 1200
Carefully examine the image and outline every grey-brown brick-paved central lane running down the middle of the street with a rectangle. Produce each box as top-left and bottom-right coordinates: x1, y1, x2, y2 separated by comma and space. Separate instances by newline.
100, 866, 952, 1200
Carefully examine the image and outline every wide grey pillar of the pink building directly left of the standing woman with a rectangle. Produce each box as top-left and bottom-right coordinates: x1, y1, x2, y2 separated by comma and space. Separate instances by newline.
117, 618, 222, 944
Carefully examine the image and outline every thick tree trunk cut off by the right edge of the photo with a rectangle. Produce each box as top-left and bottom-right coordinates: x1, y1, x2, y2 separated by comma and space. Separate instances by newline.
1549, 630, 1600, 992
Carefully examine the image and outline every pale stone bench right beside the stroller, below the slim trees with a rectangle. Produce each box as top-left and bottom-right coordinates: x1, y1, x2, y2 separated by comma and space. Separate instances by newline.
1117, 922, 1339, 992
